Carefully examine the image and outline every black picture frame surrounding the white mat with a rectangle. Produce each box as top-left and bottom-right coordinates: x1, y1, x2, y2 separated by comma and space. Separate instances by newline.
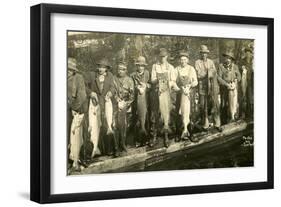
30, 4, 274, 203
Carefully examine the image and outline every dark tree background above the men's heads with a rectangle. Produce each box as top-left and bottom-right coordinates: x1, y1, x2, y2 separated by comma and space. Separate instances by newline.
68, 32, 254, 73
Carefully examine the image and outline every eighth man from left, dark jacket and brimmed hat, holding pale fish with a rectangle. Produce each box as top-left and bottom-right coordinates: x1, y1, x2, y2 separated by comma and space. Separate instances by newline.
218, 51, 241, 123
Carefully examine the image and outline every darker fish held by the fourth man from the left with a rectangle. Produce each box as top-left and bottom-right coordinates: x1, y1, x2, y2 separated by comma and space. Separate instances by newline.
137, 86, 147, 135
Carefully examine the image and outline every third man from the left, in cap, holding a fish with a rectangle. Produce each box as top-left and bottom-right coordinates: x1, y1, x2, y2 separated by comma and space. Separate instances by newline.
114, 61, 134, 152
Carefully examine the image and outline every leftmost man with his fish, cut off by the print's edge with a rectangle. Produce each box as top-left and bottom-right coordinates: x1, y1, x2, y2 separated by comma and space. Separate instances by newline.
67, 58, 88, 171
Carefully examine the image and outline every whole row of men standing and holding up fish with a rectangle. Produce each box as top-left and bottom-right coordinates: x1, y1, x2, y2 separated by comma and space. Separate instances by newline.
68, 45, 253, 169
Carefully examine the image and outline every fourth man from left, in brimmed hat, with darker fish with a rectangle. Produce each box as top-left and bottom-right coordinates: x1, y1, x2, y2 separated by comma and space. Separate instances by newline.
131, 56, 153, 147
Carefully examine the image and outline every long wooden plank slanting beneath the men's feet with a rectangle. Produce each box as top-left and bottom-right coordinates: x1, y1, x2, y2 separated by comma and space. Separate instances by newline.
69, 120, 253, 175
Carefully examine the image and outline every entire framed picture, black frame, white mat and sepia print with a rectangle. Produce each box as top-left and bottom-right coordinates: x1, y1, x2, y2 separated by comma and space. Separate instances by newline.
30, 4, 274, 203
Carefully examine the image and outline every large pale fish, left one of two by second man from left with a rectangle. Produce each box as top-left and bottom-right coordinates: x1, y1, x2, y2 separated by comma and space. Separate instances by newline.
88, 98, 101, 157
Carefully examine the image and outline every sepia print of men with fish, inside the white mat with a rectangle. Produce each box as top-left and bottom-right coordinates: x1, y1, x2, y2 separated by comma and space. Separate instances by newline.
65, 30, 255, 175
